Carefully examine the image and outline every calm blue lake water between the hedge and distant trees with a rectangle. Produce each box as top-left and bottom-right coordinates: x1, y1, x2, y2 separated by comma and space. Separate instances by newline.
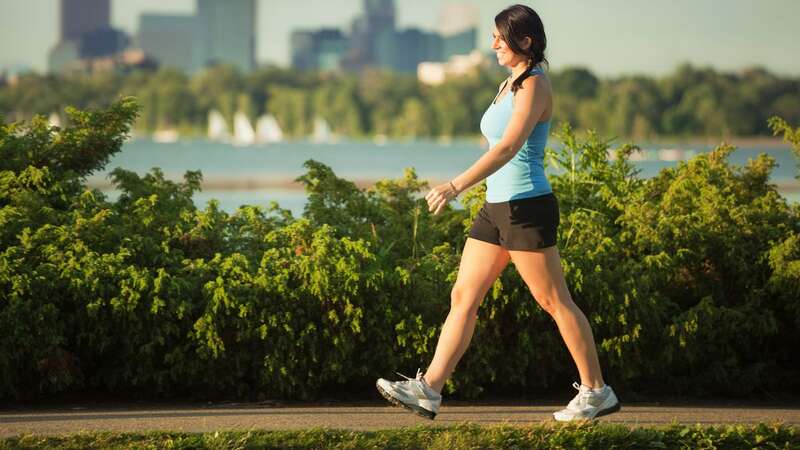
87, 139, 800, 216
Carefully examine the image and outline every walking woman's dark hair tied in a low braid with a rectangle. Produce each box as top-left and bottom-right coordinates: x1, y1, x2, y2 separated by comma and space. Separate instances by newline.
494, 5, 547, 93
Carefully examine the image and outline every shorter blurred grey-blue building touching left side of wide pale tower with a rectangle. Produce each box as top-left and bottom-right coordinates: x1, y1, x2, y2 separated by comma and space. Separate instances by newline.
136, 14, 198, 73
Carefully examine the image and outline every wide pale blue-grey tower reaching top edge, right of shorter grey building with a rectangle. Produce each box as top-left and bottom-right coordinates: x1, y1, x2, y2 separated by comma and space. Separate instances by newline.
193, 0, 256, 71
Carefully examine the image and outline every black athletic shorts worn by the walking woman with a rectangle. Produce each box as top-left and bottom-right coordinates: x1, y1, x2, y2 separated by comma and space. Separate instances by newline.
469, 192, 559, 250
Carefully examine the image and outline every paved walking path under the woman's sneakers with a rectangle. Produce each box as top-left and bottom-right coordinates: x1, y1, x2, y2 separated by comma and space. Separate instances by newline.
0, 402, 800, 437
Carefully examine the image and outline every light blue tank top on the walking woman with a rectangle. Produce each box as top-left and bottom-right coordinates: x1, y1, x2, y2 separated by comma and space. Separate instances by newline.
481, 68, 553, 203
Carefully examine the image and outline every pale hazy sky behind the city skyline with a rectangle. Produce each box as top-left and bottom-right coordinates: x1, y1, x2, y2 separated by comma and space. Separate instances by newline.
0, 0, 800, 76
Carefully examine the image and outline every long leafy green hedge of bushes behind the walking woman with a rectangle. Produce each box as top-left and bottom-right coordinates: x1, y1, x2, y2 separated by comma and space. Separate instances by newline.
0, 98, 800, 399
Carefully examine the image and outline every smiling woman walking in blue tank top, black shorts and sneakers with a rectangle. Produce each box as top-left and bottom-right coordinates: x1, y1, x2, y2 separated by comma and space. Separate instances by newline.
377, 5, 620, 421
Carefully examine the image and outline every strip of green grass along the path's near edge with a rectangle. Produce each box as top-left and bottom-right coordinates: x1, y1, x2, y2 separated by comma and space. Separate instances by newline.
0, 422, 800, 450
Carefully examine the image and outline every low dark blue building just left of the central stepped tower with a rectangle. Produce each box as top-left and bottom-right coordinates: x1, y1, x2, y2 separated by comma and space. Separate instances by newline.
290, 29, 349, 71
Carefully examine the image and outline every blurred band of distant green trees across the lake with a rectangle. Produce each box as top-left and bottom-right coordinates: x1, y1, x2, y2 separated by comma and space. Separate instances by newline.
0, 64, 800, 139
